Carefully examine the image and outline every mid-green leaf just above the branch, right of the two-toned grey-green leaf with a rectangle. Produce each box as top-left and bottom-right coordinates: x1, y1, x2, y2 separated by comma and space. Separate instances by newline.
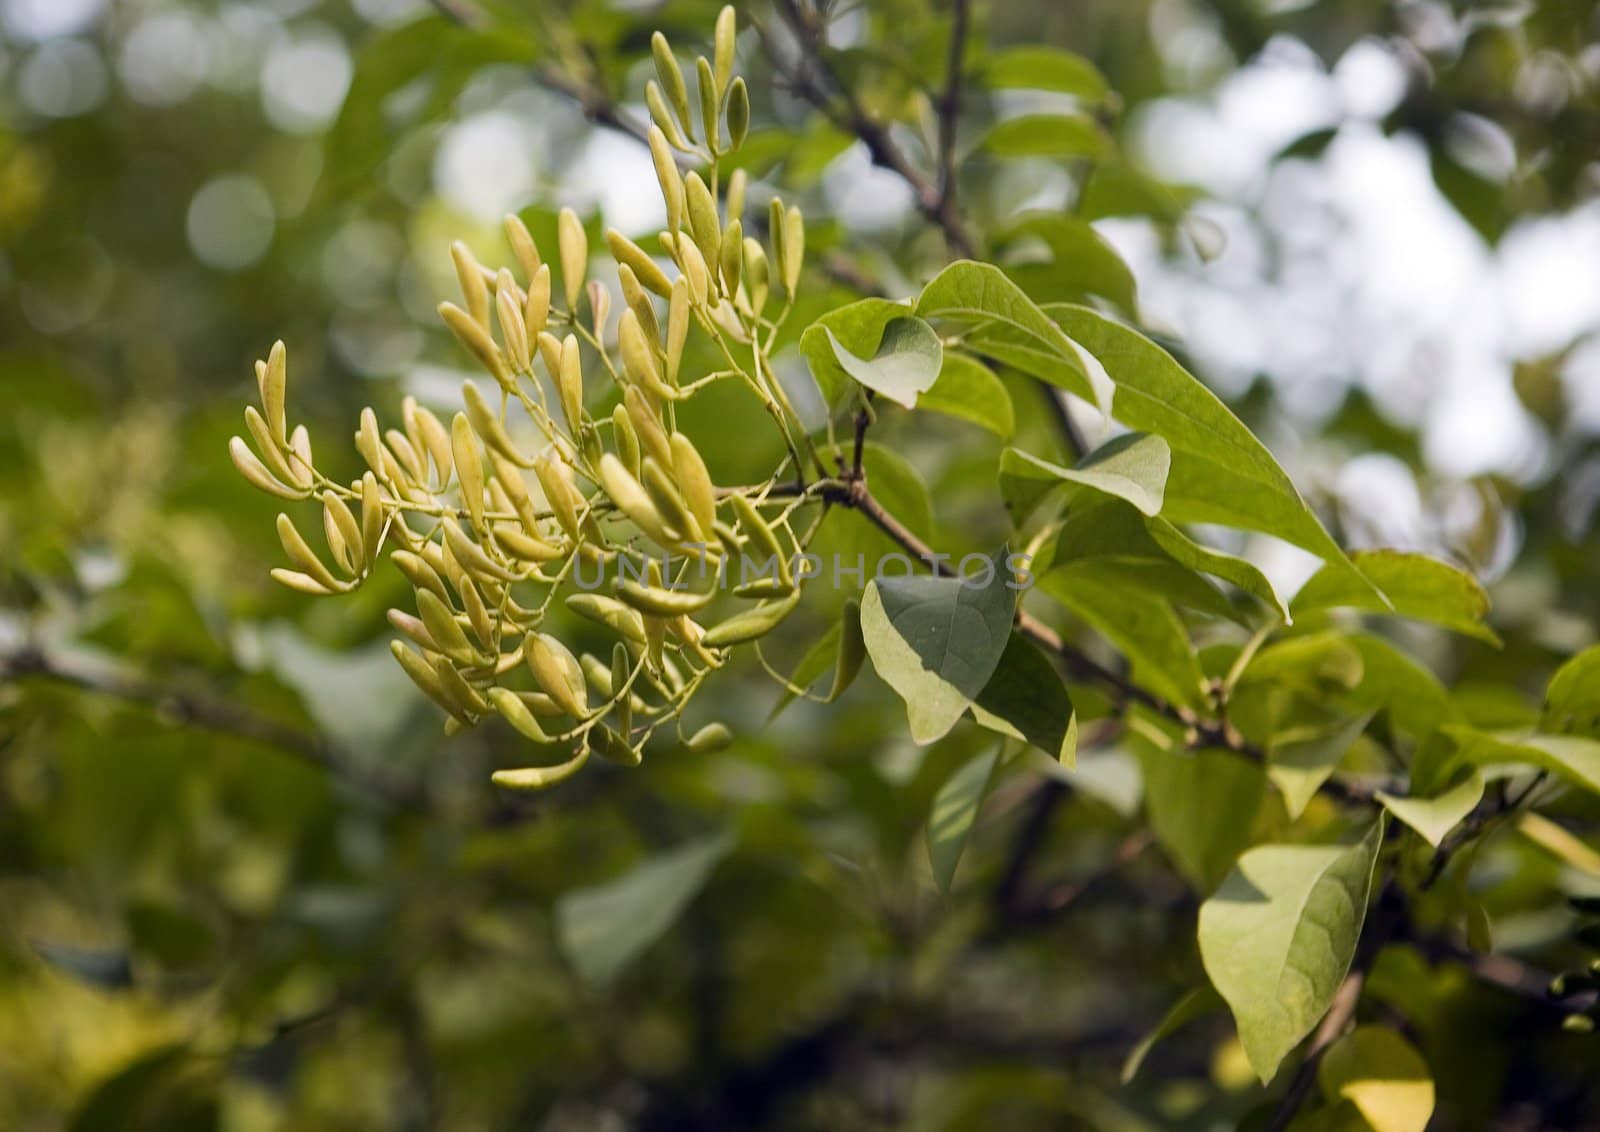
1038, 560, 1205, 707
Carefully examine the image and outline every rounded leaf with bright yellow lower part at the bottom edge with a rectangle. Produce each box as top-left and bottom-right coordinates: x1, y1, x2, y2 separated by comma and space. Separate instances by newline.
1317, 1026, 1434, 1132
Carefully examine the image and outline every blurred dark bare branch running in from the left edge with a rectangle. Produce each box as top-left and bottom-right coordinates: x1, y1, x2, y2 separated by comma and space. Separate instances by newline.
0, 648, 427, 809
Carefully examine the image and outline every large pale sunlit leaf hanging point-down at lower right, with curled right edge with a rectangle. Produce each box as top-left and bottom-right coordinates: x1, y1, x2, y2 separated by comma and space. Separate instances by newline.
1198, 819, 1382, 1082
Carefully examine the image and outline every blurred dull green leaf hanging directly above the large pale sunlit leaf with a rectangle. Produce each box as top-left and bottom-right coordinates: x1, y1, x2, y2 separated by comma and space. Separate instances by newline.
1139, 743, 1267, 892
